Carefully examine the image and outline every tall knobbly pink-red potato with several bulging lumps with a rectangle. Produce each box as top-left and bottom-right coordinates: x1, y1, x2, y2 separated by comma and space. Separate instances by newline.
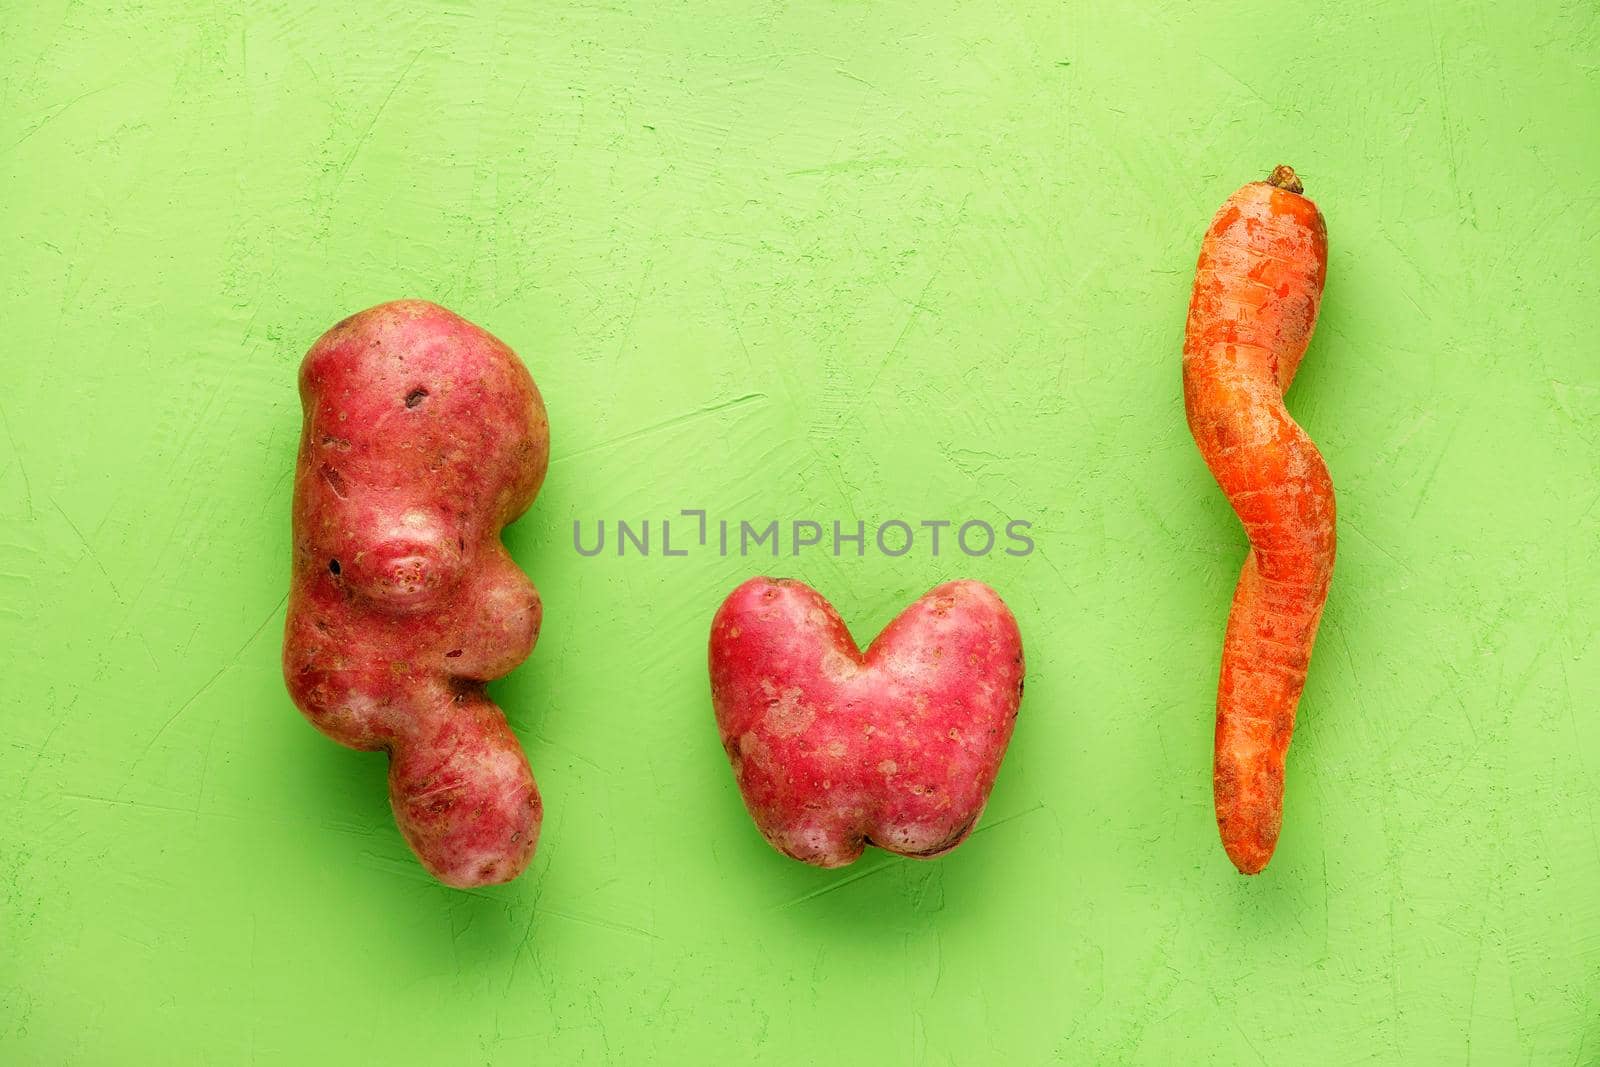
283, 301, 550, 888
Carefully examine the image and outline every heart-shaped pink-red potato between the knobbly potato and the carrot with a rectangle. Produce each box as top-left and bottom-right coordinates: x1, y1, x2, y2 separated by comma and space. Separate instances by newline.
710, 577, 1022, 867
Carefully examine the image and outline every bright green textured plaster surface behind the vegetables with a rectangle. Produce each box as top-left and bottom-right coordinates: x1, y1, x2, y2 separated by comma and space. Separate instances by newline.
0, 0, 1600, 1064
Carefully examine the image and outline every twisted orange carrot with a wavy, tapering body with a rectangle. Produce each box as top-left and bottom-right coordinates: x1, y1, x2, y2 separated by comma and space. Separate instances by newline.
1184, 166, 1334, 875
